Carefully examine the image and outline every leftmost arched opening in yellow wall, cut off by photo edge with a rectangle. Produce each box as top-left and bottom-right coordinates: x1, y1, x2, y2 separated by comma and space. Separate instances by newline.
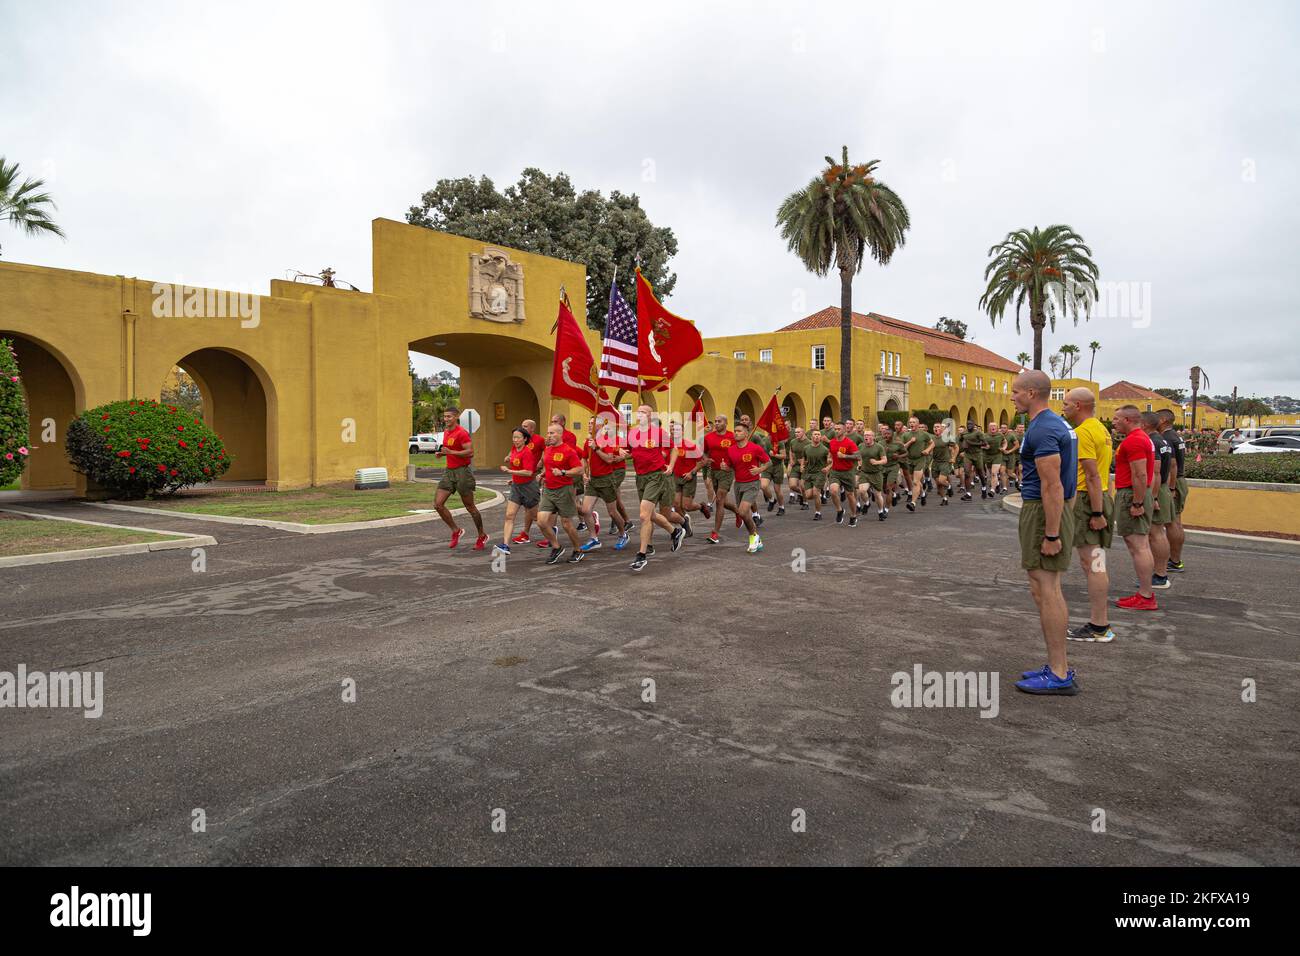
0, 330, 86, 492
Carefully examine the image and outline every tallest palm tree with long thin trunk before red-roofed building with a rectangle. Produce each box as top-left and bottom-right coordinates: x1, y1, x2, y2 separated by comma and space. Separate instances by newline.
776, 146, 911, 415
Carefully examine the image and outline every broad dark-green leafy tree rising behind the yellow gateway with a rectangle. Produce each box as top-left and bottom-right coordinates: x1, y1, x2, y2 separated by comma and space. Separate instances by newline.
407, 166, 677, 330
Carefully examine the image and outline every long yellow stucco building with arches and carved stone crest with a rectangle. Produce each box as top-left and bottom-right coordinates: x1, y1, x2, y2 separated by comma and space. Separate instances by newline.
0, 219, 1018, 492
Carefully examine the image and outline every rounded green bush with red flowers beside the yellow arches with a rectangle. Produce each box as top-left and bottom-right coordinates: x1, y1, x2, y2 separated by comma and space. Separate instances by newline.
68, 398, 233, 498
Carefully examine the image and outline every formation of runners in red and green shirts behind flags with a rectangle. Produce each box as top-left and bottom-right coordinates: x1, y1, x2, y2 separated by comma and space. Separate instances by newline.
434, 406, 1040, 571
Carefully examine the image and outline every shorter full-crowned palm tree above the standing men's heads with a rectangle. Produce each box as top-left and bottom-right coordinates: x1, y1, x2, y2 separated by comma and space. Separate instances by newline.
979, 225, 1101, 369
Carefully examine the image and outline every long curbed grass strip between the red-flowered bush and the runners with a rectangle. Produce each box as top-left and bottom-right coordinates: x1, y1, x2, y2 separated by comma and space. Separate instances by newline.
131, 481, 493, 524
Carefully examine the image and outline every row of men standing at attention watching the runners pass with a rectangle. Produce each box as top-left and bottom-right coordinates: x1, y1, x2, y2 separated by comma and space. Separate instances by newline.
1011, 371, 1188, 695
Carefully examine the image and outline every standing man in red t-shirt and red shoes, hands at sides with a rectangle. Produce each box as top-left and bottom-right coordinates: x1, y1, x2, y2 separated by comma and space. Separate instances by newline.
1110, 405, 1160, 611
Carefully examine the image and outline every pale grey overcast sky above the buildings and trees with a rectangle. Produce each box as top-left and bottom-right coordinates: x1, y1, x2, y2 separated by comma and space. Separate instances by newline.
0, 0, 1300, 395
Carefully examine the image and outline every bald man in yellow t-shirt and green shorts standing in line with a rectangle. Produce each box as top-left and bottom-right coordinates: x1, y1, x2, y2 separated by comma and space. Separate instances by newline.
1063, 388, 1115, 644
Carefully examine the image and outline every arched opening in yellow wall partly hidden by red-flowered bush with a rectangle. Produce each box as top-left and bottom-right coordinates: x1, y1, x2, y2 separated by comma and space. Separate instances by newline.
172, 349, 280, 483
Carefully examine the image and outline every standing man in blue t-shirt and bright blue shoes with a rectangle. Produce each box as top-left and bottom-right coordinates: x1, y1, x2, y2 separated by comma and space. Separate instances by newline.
1011, 369, 1079, 696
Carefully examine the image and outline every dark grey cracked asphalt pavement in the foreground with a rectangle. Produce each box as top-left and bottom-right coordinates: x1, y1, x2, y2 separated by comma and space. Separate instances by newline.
0, 481, 1300, 865
